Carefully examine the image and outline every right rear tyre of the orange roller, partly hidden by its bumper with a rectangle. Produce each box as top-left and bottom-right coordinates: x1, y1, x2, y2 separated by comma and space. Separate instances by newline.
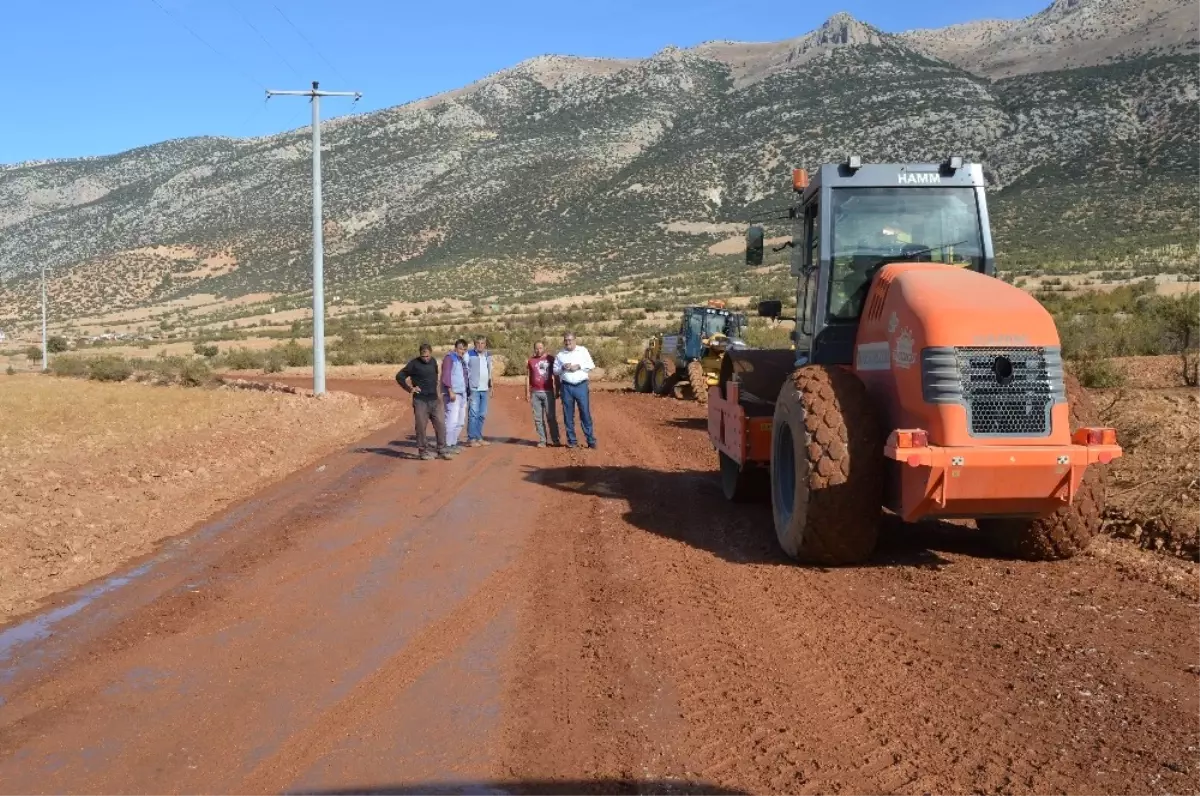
976, 375, 1108, 561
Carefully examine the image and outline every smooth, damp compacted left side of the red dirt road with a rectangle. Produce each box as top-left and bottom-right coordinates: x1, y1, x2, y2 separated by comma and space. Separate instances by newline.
0, 396, 552, 794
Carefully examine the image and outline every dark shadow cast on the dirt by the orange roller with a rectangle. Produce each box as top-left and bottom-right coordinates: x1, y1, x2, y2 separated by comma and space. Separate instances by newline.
526, 466, 995, 569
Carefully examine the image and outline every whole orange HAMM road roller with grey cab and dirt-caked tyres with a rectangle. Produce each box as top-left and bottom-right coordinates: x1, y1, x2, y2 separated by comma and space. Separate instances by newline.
708, 157, 1121, 564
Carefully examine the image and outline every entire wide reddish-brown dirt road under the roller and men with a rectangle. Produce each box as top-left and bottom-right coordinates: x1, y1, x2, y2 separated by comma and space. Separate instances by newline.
0, 383, 1200, 795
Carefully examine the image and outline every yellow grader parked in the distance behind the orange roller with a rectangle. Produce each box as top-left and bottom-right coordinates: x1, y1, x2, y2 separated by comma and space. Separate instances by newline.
628, 299, 746, 403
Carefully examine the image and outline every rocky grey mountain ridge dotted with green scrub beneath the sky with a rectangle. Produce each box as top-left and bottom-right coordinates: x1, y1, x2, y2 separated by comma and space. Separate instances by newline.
0, 0, 1200, 317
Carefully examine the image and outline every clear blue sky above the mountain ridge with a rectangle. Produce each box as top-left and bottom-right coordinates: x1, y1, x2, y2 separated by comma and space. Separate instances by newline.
0, 0, 1049, 163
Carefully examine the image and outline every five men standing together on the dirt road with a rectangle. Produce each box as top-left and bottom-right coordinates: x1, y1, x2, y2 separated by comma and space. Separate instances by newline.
396, 331, 596, 460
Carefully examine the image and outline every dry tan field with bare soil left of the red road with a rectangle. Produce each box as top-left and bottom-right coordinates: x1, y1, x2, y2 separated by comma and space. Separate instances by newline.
0, 376, 392, 622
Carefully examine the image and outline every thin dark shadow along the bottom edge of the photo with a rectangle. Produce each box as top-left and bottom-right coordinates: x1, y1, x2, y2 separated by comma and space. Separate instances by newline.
281, 779, 750, 796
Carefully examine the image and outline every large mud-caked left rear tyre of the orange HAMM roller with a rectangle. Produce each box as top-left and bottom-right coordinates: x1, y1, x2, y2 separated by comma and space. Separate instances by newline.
770, 365, 886, 565
